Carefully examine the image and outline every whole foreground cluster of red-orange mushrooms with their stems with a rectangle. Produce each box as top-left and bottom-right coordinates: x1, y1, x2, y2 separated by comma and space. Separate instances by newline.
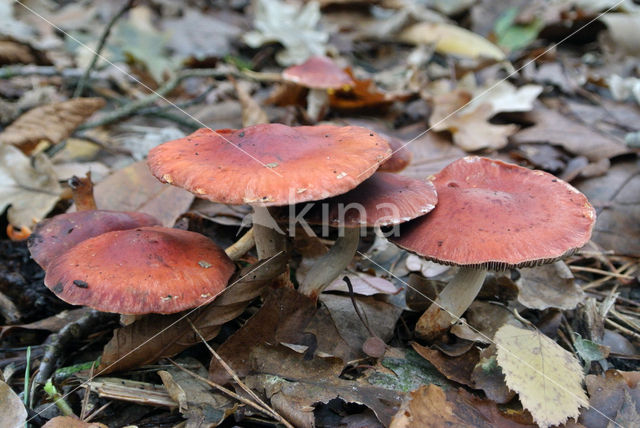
29, 113, 595, 344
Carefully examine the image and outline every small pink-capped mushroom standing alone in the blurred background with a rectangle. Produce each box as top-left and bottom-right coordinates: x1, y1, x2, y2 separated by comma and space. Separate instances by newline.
282, 56, 355, 122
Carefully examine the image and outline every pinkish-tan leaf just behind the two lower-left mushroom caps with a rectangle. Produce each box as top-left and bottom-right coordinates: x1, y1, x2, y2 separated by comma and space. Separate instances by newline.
93, 161, 194, 227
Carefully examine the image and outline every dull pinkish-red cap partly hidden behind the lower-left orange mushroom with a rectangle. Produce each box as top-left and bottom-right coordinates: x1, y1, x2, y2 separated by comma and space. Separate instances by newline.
27, 210, 160, 270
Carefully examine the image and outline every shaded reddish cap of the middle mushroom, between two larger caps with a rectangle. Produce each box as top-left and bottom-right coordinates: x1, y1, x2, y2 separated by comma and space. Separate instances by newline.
278, 172, 438, 227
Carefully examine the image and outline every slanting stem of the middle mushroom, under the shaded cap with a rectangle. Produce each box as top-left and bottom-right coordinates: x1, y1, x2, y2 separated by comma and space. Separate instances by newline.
298, 227, 360, 299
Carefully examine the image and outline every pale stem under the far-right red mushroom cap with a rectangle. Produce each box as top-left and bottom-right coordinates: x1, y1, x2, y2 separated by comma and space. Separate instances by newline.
416, 266, 487, 339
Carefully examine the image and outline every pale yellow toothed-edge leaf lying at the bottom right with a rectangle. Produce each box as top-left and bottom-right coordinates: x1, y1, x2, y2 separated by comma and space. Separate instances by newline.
494, 324, 588, 427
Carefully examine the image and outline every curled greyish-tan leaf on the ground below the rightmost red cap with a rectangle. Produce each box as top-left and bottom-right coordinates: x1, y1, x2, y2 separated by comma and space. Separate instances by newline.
516, 260, 585, 310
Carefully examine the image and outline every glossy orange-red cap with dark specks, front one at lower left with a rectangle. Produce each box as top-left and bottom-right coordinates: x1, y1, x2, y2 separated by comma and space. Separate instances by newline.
44, 226, 235, 315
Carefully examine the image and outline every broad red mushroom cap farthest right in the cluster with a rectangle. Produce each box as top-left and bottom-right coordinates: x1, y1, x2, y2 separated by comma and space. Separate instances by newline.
390, 156, 596, 270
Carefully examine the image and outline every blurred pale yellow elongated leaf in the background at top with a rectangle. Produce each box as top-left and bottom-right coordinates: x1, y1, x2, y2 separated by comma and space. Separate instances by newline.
398, 22, 505, 61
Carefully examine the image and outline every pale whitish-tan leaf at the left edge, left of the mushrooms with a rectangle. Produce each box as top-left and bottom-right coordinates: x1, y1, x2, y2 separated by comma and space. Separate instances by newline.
0, 144, 62, 227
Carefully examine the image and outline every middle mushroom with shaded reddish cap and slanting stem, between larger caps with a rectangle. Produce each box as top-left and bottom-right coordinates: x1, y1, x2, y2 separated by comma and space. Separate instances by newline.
289, 172, 438, 297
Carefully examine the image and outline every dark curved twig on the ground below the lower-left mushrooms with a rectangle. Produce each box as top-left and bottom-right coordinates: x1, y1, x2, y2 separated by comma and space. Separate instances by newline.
33, 311, 117, 385
